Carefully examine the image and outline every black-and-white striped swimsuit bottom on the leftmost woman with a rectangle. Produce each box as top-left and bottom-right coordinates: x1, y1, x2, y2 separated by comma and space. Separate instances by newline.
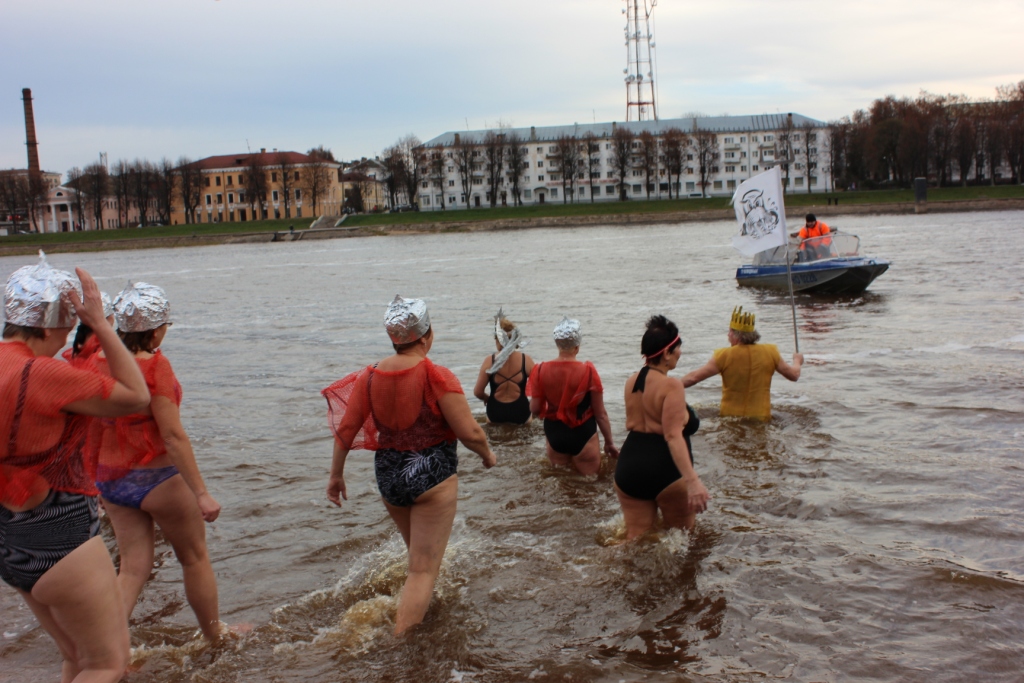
0, 490, 99, 593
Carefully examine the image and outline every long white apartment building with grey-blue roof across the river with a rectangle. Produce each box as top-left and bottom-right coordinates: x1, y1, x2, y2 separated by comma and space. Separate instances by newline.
417, 114, 831, 211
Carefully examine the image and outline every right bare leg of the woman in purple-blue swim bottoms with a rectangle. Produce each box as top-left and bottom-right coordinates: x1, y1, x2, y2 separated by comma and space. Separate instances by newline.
142, 474, 221, 640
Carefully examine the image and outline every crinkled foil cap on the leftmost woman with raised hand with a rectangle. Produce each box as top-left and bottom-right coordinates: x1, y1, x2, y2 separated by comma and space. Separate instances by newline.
3, 250, 82, 329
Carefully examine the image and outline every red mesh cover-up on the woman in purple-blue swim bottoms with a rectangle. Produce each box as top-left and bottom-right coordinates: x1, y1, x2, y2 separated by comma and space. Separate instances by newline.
90, 349, 181, 481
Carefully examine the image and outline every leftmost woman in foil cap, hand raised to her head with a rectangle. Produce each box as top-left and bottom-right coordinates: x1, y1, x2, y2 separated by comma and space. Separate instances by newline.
0, 254, 150, 683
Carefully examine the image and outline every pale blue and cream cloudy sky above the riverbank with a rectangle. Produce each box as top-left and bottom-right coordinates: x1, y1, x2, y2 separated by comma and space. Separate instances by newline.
0, 0, 1024, 173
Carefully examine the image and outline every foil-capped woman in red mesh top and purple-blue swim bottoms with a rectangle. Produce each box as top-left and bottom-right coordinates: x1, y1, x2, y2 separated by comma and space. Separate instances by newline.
92, 283, 226, 641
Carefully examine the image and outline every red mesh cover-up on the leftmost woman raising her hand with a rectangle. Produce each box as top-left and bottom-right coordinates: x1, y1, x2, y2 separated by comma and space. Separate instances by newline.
0, 342, 116, 507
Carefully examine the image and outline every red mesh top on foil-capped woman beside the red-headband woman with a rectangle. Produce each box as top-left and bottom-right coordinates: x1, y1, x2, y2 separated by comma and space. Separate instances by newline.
526, 360, 604, 427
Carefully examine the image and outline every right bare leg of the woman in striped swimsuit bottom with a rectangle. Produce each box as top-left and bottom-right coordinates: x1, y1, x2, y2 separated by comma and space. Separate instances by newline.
22, 537, 128, 683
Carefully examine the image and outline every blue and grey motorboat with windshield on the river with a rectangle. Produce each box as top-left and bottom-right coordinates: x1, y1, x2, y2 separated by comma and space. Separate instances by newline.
736, 232, 889, 294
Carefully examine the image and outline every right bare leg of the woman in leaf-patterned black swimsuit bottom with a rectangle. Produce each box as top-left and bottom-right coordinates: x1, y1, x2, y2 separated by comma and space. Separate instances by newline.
388, 475, 459, 635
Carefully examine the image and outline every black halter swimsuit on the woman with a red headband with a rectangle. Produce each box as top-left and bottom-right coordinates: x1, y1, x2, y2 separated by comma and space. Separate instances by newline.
615, 368, 700, 501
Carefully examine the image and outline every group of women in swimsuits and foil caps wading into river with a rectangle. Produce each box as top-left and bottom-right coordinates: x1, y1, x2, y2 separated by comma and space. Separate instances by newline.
0, 256, 800, 682
